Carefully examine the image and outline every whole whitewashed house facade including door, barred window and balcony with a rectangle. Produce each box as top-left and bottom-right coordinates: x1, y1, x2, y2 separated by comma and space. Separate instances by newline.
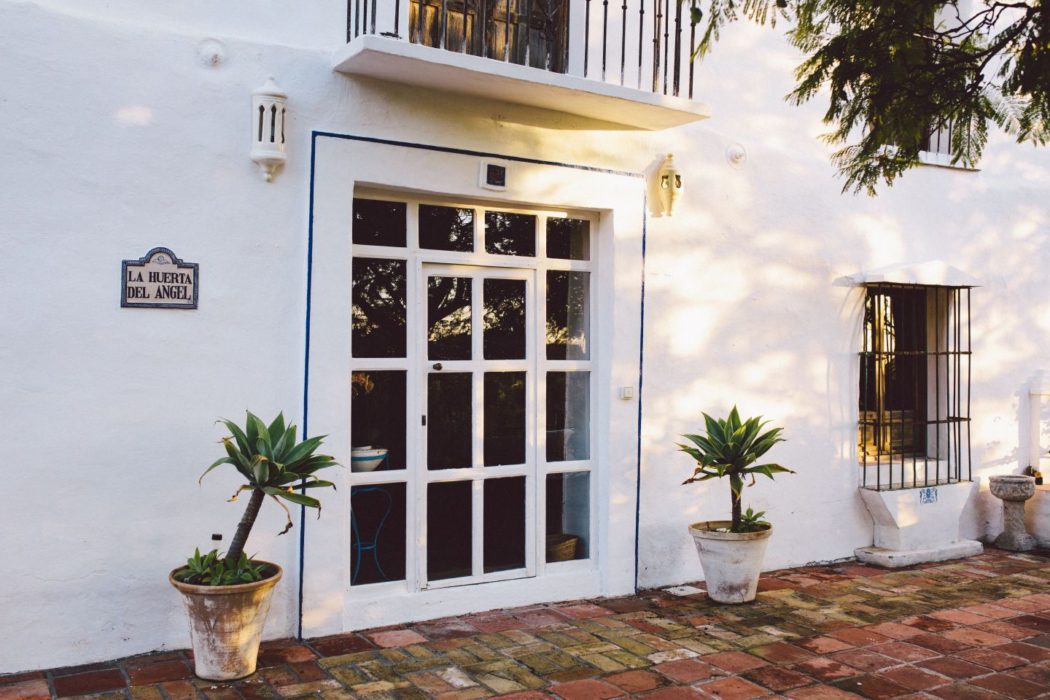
0, 0, 1050, 673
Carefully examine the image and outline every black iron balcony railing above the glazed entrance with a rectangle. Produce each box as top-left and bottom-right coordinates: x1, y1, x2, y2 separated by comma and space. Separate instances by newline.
347, 0, 696, 100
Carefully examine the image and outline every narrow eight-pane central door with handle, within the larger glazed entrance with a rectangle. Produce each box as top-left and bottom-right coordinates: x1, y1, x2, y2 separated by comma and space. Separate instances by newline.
421, 264, 538, 588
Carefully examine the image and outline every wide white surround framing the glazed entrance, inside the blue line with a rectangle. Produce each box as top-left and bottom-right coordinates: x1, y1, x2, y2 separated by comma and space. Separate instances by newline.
302, 134, 645, 636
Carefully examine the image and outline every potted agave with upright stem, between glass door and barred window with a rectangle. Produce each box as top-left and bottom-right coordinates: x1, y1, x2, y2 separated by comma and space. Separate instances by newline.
678, 406, 795, 602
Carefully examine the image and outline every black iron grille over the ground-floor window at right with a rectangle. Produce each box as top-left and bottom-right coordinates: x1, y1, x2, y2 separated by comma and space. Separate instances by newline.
857, 283, 972, 490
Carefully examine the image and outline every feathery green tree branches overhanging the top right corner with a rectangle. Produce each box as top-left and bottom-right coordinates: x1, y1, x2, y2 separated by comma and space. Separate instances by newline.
679, 0, 1050, 194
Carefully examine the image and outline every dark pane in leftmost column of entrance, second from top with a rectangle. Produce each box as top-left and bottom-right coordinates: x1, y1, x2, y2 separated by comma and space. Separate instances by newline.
351, 258, 406, 357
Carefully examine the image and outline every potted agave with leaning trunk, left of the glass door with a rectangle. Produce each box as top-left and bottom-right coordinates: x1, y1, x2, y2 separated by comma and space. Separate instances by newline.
168, 411, 336, 680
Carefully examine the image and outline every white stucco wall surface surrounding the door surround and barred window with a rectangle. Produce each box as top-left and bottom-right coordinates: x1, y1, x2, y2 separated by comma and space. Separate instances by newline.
0, 0, 1050, 673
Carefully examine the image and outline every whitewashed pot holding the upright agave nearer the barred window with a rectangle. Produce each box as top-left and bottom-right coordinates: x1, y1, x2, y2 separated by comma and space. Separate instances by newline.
689, 521, 773, 603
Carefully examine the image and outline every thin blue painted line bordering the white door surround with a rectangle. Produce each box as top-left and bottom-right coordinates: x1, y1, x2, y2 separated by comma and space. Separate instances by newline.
297, 130, 649, 639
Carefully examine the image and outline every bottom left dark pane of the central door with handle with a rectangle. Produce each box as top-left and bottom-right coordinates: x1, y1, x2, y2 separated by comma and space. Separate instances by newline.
426, 482, 474, 580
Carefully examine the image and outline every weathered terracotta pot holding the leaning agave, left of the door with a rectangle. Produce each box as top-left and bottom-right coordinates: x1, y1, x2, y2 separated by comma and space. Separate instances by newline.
168, 561, 284, 680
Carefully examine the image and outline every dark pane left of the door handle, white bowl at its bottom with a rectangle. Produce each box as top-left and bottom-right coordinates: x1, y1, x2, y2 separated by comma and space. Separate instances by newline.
350, 370, 407, 470
